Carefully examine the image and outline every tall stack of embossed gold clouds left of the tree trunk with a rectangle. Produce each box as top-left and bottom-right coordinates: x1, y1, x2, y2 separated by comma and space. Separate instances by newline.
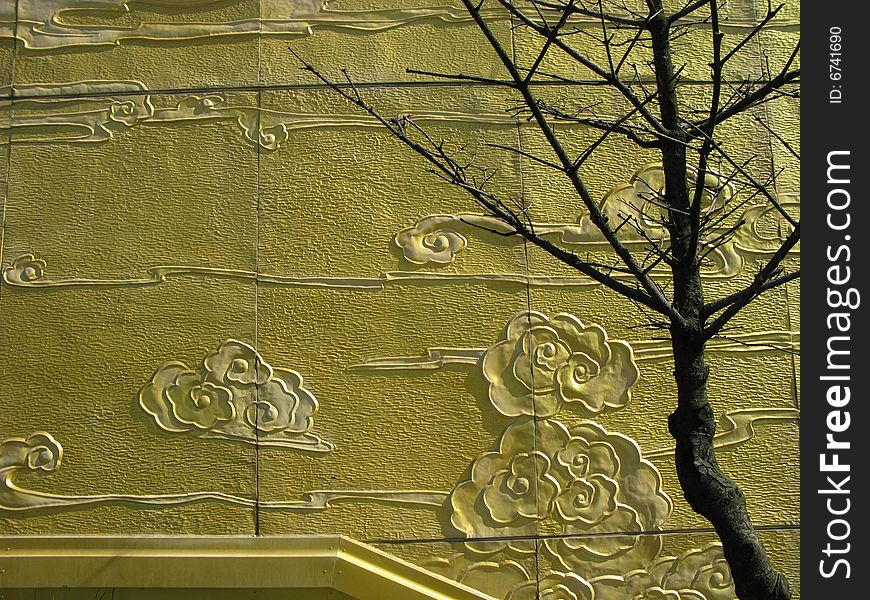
427, 311, 734, 600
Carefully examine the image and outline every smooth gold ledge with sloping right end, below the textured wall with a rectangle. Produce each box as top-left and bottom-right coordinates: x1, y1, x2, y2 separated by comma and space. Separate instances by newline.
0, 536, 491, 600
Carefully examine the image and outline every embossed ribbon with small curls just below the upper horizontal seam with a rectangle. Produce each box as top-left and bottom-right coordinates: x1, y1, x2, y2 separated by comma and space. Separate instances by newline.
0, 91, 516, 150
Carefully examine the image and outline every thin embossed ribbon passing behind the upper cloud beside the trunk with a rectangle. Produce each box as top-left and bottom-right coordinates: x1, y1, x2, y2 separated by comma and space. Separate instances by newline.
348, 331, 800, 372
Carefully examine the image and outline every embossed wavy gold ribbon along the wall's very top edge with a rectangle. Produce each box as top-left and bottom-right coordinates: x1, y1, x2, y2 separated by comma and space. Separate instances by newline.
0, 0, 799, 50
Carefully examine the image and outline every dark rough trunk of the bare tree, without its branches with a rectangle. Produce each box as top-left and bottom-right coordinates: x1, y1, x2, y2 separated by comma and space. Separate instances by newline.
649, 0, 791, 600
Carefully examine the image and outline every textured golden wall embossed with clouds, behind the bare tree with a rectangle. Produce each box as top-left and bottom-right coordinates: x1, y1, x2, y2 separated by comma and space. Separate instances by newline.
0, 0, 799, 600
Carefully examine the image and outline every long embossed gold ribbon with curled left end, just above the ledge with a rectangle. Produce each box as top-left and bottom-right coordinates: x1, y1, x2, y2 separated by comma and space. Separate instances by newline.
0, 432, 449, 517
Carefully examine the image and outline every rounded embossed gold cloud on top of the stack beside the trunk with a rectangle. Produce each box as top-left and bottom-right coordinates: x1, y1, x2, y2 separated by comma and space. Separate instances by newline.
481, 312, 639, 417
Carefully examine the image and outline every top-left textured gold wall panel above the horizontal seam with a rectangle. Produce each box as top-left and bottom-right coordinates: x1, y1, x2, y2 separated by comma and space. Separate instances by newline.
15, 0, 260, 94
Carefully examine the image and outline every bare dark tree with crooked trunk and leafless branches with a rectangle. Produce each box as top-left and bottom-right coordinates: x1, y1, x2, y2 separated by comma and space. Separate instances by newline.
297, 0, 800, 600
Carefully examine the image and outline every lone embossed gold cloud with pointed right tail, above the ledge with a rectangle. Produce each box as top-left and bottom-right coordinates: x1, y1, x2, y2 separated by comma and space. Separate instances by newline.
139, 340, 333, 452
